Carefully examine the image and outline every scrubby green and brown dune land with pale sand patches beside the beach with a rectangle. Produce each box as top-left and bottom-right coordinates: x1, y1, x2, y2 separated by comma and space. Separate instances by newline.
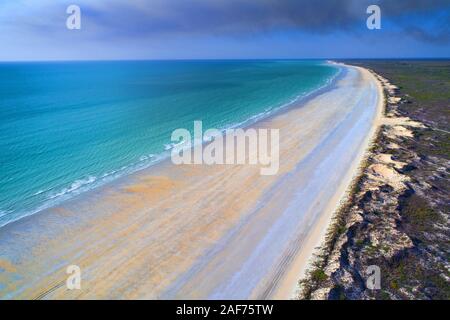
299, 60, 450, 299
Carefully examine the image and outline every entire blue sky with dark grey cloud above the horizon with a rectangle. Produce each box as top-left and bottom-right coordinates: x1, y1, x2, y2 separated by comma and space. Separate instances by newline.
0, 0, 450, 61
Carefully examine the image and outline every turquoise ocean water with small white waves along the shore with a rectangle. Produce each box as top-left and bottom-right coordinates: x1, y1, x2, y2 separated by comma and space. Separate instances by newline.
0, 60, 338, 226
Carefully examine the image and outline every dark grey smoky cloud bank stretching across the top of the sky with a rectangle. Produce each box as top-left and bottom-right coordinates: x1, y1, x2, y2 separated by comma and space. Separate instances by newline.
74, 0, 450, 42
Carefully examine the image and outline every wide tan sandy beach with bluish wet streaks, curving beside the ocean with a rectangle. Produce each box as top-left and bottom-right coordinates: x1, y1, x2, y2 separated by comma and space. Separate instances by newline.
0, 66, 383, 299
